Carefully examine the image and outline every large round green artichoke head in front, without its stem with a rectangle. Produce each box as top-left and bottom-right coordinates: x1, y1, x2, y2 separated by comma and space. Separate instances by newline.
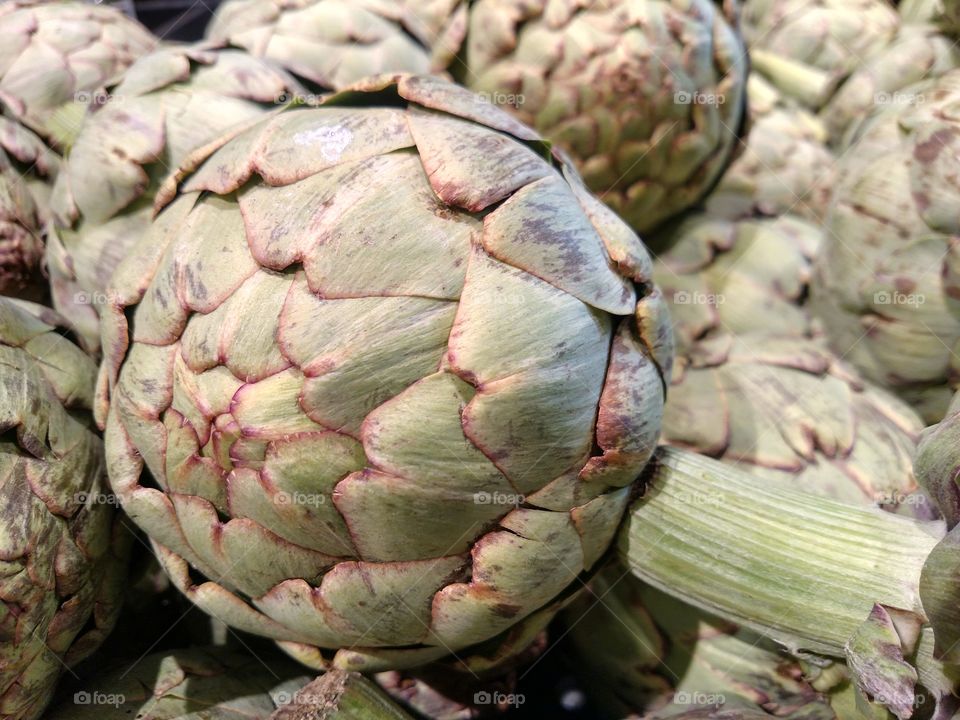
98, 76, 672, 670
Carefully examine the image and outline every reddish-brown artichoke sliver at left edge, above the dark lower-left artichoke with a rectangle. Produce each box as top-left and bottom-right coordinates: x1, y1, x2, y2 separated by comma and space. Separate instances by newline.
0, 116, 59, 300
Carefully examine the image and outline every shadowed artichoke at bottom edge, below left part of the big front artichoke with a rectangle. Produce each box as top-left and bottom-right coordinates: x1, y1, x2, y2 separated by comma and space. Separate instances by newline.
47, 648, 311, 720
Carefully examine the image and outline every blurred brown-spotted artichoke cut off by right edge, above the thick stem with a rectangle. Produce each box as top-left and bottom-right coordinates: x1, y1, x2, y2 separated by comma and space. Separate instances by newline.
811, 71, 960, 421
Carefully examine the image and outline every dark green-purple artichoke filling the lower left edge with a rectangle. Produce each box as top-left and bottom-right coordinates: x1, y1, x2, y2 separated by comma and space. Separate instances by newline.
0, 298, 130, 720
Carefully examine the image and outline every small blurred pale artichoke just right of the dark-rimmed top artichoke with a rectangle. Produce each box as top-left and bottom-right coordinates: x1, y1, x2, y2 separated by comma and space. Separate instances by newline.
706, 73, 834, 224
